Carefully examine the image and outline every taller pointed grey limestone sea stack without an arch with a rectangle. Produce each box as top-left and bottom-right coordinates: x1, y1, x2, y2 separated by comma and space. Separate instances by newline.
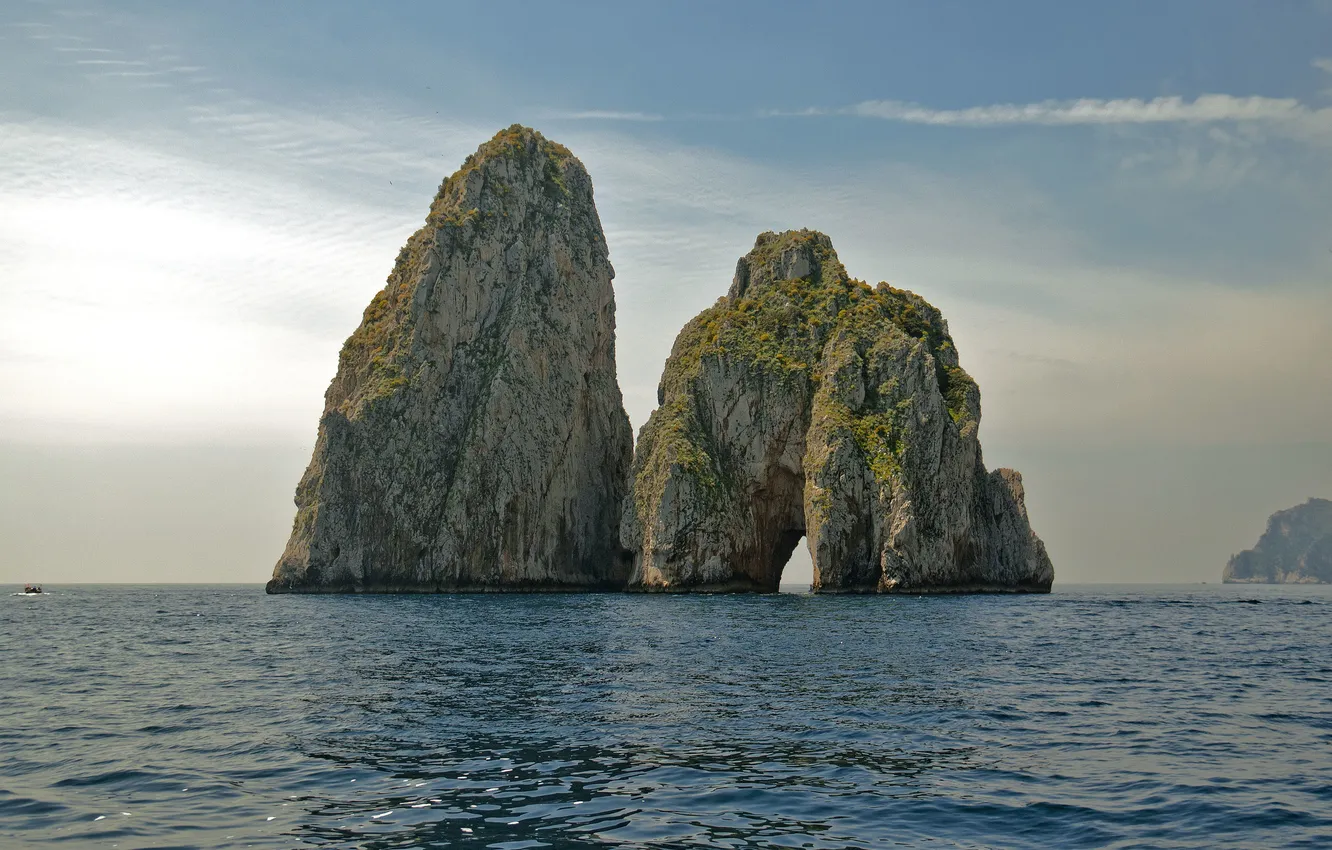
268, 125, 633, 593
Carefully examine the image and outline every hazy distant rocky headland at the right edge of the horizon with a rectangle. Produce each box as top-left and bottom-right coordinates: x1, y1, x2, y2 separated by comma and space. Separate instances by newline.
1221, 498, 1332, 585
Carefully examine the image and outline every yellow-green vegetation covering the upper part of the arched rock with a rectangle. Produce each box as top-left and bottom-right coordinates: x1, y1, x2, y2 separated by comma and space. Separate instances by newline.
635, 230, 979, 519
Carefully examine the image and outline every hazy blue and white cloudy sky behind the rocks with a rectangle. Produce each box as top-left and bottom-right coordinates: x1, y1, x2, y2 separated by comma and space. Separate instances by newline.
0, 0, 1332, 584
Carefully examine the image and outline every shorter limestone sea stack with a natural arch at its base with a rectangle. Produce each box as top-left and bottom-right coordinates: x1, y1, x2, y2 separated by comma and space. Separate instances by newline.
621, 230, 1054, 593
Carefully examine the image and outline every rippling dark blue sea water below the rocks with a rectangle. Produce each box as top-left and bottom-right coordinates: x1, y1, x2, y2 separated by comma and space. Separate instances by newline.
0, 586, 1332, 849
